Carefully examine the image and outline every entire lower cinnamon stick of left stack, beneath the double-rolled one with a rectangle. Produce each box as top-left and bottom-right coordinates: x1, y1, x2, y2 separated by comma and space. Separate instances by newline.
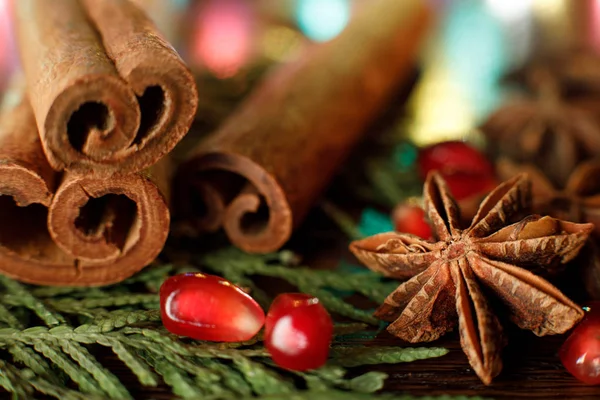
0, 89, 169, 286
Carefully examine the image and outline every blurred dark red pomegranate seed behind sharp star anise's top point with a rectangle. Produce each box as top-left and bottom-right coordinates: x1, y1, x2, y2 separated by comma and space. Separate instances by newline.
417, 141, 494, 178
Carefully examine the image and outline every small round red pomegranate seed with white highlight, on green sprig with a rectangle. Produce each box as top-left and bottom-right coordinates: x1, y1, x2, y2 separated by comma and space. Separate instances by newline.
265, 293, 333, 371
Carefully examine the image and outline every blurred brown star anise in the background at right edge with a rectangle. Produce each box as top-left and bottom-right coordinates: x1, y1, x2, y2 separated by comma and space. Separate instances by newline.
480, 66, 600, 186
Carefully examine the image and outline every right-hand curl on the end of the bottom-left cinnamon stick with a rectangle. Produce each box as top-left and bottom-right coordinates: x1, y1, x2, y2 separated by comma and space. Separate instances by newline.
43, 174, 170, 284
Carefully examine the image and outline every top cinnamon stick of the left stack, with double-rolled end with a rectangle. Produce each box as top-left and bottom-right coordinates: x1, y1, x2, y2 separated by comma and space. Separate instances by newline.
14, 0, 198, 174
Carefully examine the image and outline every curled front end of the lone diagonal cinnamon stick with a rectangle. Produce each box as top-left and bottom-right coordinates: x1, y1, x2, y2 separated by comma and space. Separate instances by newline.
175, 153, 293, 253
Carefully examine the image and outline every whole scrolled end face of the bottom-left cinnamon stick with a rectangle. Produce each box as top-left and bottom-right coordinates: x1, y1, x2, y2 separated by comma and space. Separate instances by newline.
0, 168, 170, 286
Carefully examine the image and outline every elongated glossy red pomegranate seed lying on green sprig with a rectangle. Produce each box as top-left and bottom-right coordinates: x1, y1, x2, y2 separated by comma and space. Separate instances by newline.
160, 273, 265, 342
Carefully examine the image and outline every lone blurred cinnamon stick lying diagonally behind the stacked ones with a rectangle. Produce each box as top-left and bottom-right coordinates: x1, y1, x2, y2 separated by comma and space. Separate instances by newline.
177, 0, 431, 252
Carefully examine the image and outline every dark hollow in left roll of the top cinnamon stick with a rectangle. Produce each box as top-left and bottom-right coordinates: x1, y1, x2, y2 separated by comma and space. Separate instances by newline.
67, 102, 115, 154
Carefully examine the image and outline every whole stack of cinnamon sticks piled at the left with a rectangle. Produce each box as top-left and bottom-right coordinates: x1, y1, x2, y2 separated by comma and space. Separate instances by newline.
0, 1, 197, 286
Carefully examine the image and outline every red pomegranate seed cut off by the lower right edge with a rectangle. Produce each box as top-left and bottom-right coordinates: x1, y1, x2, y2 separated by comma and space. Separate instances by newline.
559, 302, 600, 385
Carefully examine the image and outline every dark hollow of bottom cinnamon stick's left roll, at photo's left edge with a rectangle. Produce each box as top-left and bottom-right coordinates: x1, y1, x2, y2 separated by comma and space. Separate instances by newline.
0, 195, 70, 264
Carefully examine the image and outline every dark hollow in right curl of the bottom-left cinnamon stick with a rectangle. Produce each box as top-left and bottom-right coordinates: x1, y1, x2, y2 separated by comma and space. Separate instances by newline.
75, 194, 137, 250
